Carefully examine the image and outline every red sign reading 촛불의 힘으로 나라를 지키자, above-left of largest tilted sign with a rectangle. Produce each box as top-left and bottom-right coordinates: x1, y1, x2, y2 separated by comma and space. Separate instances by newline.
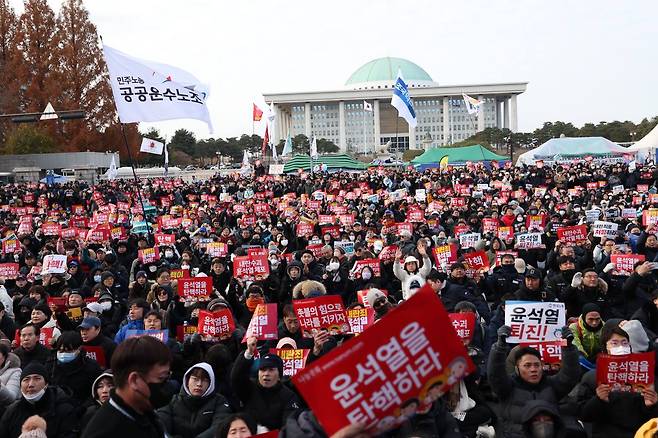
292, 295, 350, 337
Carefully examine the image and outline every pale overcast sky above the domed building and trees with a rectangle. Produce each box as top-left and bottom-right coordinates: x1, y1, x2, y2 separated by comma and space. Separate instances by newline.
11, 0, 658, 138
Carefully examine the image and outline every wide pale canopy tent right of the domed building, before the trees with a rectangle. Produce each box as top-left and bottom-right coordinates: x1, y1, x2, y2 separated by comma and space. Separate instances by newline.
516, 137, 628, 166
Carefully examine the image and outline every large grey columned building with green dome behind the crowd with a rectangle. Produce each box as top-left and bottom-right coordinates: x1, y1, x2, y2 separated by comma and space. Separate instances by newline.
264, 57, 528, 154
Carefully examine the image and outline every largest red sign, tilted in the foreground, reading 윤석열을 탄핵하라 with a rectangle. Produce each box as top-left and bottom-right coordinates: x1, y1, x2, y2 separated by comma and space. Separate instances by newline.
293, 285, 474, 435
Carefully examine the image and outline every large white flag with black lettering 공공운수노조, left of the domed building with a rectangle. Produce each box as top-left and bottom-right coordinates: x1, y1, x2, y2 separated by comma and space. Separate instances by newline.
103, 46, 212, 132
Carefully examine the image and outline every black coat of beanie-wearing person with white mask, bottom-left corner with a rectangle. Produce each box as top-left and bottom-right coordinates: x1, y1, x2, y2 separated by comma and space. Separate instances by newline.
0, 386, 78, 438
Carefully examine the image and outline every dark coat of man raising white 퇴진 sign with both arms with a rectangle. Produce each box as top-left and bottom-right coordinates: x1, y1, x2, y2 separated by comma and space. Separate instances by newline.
487, 342, 580, 438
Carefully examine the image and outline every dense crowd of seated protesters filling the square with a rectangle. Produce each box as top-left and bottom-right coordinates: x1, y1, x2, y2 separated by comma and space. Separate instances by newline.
0, 160, 658, 438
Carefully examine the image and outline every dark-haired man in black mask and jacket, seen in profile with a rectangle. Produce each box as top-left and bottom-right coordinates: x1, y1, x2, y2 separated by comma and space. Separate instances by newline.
82, 336, 171, 438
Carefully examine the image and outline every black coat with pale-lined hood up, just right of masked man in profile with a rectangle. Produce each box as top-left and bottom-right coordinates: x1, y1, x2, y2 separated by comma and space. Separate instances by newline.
158, 362, 231, 438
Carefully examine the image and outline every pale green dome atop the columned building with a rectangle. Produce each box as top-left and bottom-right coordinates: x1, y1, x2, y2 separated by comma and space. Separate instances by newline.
345, 57, 433, 85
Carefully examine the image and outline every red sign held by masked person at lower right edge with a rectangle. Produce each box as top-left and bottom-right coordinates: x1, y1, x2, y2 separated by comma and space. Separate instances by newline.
596, 351, 656, 392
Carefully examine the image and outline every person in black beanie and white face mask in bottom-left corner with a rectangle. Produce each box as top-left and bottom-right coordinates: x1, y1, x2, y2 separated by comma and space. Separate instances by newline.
0, 362, 78, 438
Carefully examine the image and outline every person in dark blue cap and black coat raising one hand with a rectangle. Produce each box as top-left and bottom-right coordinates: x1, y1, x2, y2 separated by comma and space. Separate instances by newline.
231, 337, 299, 430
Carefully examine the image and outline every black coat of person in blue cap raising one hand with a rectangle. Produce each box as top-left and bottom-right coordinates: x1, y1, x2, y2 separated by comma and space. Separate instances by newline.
231, 353, 299, 430
